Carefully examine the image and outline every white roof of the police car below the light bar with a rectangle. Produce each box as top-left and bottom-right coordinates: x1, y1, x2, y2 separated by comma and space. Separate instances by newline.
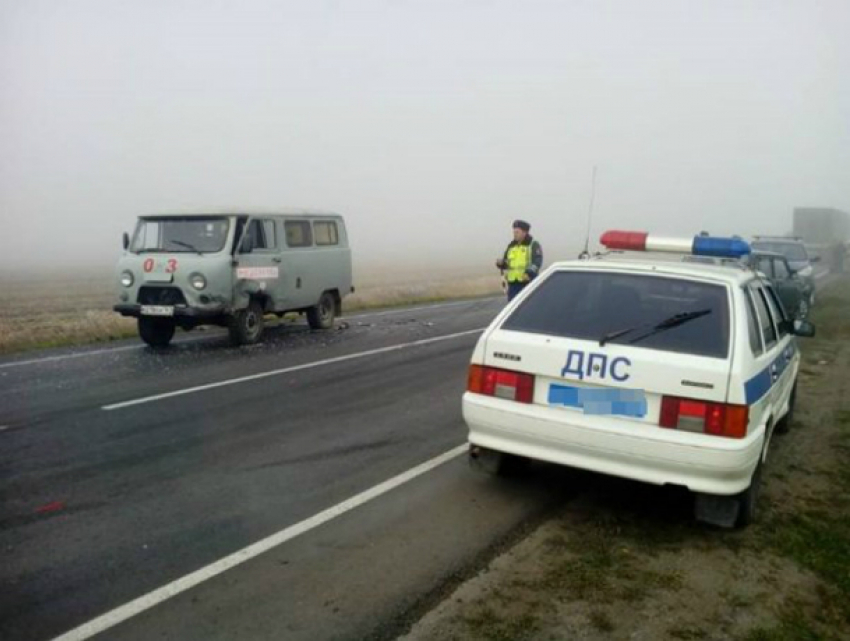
552, 253, 755, 285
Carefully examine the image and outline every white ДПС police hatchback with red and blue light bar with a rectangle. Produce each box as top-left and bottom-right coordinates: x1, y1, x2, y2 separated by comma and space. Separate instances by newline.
463, 231, 814, 527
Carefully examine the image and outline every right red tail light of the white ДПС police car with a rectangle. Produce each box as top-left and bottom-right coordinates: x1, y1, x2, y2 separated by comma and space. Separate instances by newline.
658, 396, 749, 438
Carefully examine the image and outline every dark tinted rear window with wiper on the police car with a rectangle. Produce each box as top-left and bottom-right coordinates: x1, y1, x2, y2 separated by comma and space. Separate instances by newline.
502, 271, 729, 358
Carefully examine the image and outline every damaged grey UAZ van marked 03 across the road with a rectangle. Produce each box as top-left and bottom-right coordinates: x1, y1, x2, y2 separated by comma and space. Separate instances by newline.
114, 213, 354, 347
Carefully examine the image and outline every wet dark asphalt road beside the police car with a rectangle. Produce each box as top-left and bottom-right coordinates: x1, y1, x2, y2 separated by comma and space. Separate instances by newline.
0, 299, 570, 641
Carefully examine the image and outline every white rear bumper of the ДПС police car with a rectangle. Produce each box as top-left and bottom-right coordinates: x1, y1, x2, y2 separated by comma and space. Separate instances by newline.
463, 393, 764, 495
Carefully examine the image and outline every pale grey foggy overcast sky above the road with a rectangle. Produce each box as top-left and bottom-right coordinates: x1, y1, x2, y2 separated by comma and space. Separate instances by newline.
0, 0, 850, 269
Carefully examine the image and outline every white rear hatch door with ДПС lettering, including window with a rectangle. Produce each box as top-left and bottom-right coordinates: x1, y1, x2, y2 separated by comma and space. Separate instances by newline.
484, 268, 730, 433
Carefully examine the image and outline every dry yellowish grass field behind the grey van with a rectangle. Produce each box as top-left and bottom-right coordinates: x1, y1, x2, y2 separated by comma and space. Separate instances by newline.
0, 268, 500, 354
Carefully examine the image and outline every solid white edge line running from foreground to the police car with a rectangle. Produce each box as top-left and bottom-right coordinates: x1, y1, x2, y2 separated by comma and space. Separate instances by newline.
49, 444, 467, 641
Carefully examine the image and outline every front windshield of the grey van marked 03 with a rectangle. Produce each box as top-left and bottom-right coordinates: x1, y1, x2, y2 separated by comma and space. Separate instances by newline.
130, 216, 230, 254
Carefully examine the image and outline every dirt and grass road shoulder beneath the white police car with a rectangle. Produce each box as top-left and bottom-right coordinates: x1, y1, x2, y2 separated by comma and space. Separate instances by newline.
403, 277, 850, 641
